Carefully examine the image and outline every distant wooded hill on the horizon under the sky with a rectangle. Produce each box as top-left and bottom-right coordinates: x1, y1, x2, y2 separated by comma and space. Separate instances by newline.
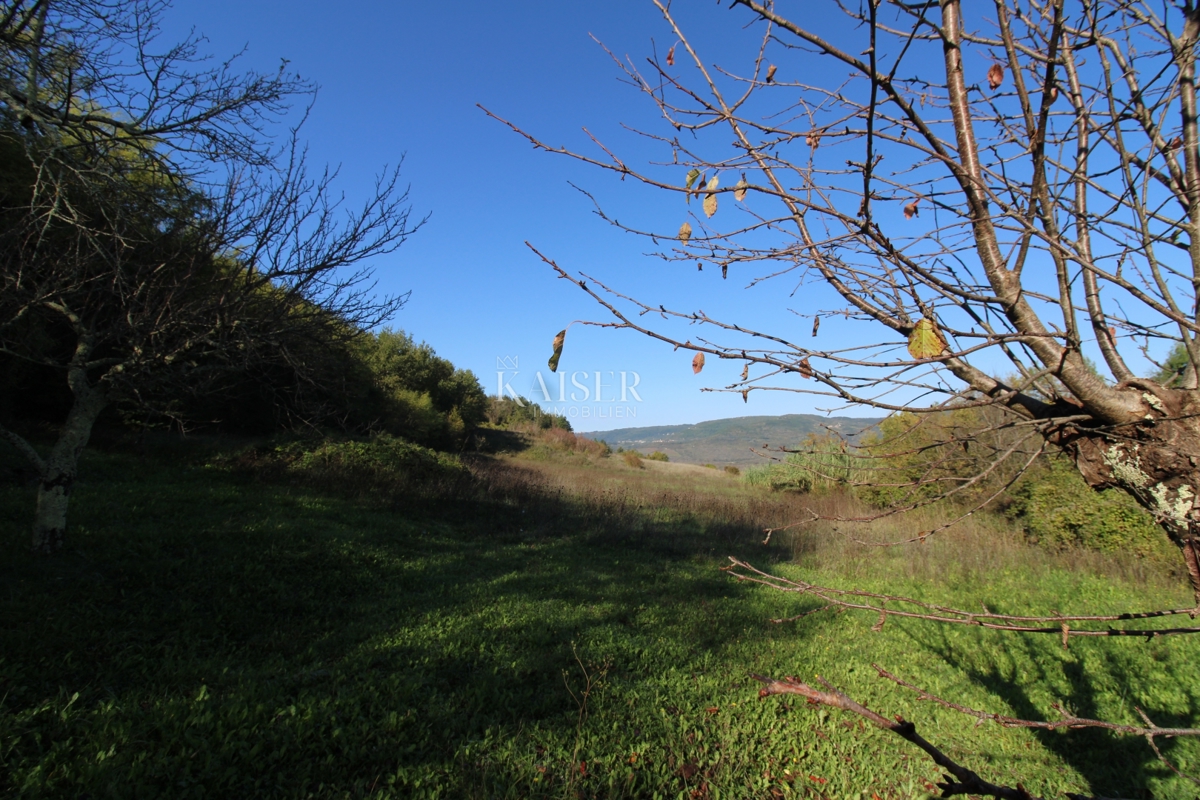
583, 414, 881, 467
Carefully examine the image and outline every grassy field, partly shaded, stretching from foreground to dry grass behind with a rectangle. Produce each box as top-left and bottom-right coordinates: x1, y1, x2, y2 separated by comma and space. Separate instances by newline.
0, 434, 1200, 800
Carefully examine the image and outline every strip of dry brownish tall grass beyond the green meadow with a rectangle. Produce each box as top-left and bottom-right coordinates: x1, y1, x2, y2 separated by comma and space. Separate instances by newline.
473, 434, 1178, 585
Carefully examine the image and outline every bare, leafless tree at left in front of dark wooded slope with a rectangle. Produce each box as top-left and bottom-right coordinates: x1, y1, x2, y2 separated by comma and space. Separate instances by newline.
0, 0, 419, 552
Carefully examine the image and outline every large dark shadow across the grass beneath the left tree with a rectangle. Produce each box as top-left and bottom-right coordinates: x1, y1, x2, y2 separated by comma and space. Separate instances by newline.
0, 453, 806, 796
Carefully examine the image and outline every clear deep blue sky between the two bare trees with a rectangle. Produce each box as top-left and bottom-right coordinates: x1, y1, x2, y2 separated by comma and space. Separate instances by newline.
164, 0, 1142, 431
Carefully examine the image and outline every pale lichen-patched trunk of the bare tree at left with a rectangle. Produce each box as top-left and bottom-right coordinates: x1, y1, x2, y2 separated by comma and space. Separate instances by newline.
32, 381, 107, 554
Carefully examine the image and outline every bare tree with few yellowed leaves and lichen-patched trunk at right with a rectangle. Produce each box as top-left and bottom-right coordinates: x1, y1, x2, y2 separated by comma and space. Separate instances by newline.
489, 0, 1200, 796
